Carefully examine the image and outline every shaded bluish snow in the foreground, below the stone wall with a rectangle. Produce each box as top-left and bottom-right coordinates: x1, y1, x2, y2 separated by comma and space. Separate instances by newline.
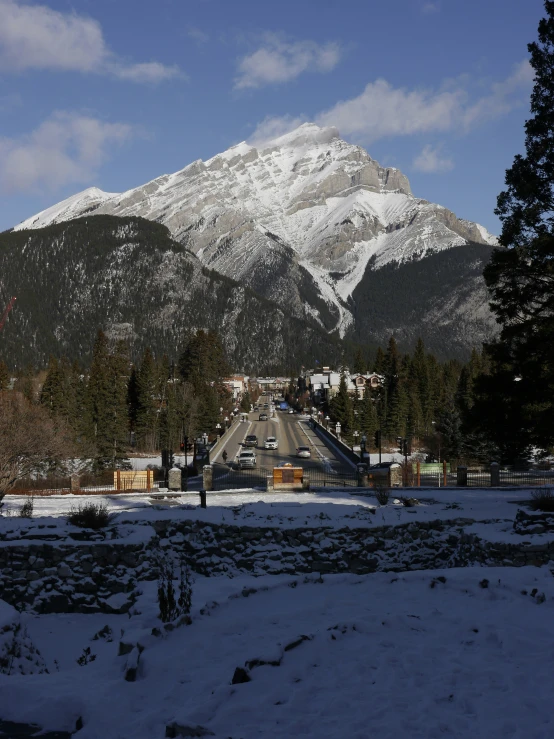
0, 568, 554, 739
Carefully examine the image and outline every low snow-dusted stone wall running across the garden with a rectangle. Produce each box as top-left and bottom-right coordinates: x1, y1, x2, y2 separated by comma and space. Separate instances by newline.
0, 514, 554, 613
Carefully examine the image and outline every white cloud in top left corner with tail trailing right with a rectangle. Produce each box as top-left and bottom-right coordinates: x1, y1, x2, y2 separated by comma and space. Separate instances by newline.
0, 0, 179, 82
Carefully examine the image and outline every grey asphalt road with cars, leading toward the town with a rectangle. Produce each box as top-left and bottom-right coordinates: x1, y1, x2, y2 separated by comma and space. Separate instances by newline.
211, 397, 354, 482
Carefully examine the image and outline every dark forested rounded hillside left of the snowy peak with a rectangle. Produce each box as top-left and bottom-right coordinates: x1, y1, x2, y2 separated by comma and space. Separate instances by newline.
0, 216, 352, 374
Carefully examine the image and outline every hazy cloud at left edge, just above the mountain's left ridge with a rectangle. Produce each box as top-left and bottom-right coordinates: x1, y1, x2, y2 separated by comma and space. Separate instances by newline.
0, 111, 135, 193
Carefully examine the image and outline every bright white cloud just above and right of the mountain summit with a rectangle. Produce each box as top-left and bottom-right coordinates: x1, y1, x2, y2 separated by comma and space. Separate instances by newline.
316, 79, 466, 142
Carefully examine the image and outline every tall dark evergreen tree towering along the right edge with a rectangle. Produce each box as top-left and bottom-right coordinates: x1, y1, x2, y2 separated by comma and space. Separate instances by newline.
479, 0, 554, 453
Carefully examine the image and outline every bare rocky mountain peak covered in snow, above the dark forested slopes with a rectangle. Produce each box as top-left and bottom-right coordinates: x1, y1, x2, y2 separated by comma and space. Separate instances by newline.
16, 123, 496, 356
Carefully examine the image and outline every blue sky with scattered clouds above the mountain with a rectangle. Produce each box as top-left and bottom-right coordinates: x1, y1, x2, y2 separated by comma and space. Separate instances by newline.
0, 0, 544, 233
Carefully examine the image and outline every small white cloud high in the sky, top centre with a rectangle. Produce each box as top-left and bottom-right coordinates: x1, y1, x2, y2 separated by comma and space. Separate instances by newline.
235, 34, 341, 89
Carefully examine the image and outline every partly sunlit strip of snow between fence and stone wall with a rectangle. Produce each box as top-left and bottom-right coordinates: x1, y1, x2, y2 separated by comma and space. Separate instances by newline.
0, 488, 549, 540
